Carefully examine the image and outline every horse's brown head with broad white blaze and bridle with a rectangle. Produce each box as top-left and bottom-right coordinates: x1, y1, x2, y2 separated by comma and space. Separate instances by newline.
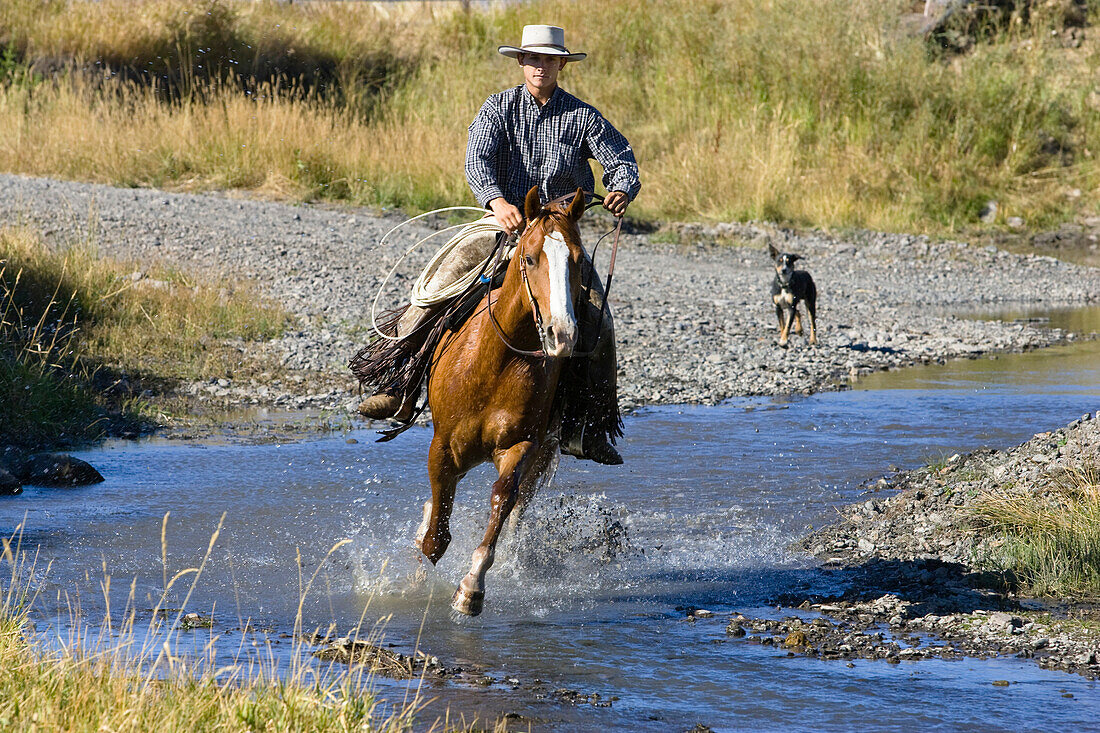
514, 186, 584, 357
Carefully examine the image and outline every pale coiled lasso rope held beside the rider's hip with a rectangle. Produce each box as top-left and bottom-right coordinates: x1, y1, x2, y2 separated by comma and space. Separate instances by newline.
371, 206, 512, 341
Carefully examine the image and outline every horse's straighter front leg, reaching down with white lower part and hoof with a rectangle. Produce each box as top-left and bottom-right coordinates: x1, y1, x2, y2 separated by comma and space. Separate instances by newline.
451, 440, 538, 616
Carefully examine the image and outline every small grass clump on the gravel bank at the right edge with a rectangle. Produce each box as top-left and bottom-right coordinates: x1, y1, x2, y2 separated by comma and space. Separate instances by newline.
976, 463, 1100, 597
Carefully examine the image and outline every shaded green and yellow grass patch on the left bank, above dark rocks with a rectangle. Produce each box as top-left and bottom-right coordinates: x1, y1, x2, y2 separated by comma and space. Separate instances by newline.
0, 229, 288, 448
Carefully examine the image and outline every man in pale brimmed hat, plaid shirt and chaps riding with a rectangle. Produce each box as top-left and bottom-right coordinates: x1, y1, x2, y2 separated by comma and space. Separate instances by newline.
360, 25, 641, 464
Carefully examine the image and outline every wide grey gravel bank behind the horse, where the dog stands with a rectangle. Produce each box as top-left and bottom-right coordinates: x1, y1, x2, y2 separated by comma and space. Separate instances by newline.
0, 169, 1100, 414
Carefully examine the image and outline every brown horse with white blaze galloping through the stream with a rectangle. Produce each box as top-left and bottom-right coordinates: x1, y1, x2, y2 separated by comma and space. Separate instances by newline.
417, 187, 584, 616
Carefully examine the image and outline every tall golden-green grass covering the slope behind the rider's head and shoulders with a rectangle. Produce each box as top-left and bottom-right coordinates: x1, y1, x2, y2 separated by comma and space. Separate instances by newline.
0, 0, 1100, 231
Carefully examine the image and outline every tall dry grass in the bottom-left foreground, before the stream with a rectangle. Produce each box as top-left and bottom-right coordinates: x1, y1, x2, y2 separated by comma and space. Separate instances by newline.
0, 517, 466, 733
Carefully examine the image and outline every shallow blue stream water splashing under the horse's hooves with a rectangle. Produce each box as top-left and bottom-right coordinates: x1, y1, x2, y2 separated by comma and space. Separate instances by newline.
0, 310, 1100, 731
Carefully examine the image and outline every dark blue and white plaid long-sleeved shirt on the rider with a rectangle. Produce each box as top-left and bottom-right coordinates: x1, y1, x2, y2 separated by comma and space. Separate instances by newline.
466, 85, 641, 209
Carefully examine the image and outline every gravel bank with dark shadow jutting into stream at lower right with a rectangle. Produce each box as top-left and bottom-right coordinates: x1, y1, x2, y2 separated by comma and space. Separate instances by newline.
721, 412, 1100, 685
